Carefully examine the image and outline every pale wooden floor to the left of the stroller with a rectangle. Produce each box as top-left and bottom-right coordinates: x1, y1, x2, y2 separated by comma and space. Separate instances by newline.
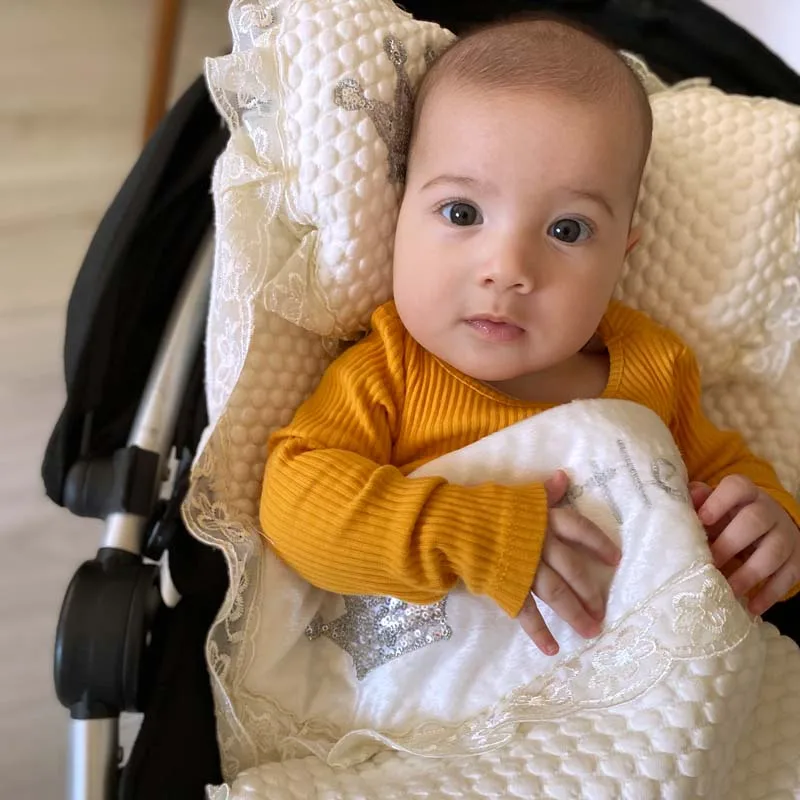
0, 0, 228, 800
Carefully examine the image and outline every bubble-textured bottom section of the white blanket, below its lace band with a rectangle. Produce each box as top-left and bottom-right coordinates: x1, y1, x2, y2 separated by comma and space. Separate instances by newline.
208, 626, 800, 800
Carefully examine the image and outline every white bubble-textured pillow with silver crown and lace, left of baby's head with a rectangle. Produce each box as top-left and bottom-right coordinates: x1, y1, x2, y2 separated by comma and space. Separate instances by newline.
206, 0, 452, 336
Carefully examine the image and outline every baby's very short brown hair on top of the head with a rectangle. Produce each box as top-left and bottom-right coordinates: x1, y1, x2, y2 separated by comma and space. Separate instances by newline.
411, 14, 653, 176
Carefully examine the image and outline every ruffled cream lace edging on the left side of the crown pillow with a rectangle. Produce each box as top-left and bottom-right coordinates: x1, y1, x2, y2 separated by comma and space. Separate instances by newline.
205, 0, 360, 340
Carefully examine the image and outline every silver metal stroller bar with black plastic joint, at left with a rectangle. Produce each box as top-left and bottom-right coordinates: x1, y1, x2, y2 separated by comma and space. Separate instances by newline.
54, 234, 213, 800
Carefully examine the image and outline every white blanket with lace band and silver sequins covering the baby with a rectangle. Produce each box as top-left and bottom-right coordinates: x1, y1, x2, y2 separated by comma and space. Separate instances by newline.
210, 400, 800, 800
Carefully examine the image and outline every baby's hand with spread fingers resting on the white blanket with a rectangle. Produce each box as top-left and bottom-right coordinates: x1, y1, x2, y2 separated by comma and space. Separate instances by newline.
518, 471, 621, 656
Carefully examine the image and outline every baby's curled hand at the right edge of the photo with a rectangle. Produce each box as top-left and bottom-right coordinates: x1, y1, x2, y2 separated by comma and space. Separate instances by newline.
689, 475, 800, 614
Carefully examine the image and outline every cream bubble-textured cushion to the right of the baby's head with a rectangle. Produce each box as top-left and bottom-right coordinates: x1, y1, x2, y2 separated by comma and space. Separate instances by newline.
620, 85, 800, 386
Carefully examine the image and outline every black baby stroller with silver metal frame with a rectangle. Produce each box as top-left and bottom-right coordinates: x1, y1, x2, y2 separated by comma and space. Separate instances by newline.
43, 0, 800, 800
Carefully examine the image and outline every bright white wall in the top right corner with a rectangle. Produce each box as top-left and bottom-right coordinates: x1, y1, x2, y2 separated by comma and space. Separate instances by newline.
705, 0, 800, 73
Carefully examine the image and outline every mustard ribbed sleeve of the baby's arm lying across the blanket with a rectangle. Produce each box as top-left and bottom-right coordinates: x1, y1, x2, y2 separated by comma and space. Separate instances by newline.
261, 312, 548, 616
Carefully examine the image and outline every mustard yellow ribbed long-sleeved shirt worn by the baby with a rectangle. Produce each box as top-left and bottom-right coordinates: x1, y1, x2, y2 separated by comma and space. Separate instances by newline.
261, 303, 800, 616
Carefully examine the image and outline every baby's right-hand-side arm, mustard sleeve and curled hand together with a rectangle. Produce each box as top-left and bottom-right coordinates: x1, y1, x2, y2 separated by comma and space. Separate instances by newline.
673, 349, 800, 613
